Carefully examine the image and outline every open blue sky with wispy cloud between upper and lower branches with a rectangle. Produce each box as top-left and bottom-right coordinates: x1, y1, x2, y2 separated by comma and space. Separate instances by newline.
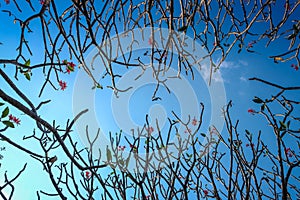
0, 0, 300, 199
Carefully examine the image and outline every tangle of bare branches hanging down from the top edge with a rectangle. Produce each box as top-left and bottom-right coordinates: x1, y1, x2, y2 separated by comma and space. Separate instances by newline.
0, 0, 300, 96
